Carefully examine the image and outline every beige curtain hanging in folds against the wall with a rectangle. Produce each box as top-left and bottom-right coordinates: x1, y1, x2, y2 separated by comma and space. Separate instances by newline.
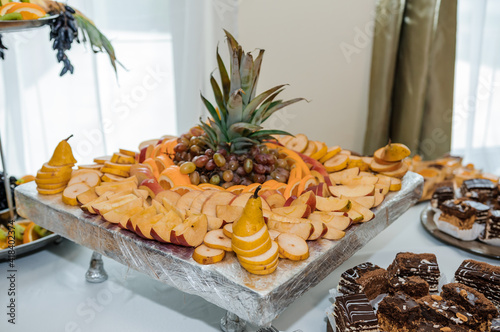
364, 0, 457, 159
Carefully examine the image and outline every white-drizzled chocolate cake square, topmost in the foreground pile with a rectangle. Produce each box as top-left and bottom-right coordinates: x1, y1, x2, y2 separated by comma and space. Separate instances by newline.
387, 252, 441, 292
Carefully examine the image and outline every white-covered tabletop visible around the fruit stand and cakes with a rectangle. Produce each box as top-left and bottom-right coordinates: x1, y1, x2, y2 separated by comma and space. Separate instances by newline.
0, 204, 500, 332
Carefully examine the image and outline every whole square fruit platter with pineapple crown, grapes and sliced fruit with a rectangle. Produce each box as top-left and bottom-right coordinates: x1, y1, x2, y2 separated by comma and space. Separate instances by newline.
16, 32, 423, 326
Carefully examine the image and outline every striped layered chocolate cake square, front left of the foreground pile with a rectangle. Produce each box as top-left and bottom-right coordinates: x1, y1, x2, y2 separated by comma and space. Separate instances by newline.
333, 294, 379, 332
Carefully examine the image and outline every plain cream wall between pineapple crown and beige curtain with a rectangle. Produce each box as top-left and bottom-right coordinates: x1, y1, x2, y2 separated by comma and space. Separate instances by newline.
238, 0, 376, 151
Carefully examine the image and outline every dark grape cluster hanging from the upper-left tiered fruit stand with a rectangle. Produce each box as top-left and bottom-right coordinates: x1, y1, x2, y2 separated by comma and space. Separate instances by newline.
50, 6, 79, 76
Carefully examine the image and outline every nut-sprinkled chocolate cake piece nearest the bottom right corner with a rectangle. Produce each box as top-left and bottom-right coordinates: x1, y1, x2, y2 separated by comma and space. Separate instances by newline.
441, 283, 498, 331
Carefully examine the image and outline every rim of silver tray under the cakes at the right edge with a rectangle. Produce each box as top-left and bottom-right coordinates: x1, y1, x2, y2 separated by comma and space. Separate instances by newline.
420, 205, 500, 259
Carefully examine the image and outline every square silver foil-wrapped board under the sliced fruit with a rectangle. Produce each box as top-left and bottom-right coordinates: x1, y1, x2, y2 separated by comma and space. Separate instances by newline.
16, 172, 423, 326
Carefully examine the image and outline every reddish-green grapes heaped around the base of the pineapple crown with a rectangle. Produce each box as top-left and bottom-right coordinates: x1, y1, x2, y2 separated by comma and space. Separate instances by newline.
173, 128, 290, 189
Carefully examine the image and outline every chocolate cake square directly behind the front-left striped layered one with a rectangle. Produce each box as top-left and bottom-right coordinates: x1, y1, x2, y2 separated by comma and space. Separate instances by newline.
338, 262, 388, 300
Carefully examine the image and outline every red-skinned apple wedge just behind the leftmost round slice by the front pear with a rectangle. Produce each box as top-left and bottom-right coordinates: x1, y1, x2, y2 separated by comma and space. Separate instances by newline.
170, 214, 208, 247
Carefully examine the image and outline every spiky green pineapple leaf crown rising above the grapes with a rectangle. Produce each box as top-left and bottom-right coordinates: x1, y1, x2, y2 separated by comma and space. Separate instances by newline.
200, 30, 305, 154
